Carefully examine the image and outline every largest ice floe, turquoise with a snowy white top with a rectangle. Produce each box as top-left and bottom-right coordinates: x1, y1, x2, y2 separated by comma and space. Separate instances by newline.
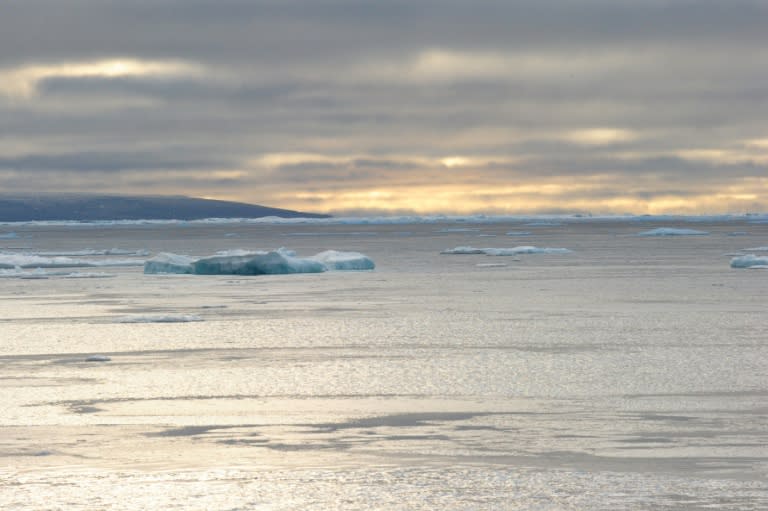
144, 248, 376, 275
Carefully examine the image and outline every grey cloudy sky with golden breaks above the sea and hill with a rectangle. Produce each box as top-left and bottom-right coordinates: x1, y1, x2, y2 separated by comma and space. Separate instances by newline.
0, 0, 768, 214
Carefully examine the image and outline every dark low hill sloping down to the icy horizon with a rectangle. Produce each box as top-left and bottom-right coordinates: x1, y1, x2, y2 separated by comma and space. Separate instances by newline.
0, 194, 329, 222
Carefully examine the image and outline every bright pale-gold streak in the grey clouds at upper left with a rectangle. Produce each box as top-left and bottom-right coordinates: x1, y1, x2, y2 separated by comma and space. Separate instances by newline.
0, 59, 201, 99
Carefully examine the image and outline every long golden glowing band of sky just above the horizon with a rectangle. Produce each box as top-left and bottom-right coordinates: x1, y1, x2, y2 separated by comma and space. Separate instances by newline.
262, 176, 768, 214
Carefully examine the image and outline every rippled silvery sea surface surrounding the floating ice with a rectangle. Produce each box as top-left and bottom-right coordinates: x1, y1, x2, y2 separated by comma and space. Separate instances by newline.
0, 221, 768, 510
